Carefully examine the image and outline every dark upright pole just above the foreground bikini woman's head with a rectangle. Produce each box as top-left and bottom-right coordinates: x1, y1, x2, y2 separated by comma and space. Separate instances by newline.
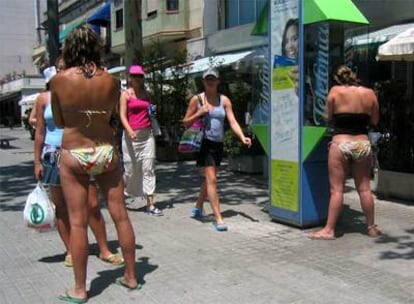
47, 0, 59, 65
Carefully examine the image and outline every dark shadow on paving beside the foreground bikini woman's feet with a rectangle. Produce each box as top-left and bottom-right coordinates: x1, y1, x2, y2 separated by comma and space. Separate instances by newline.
88, 257, 158, 298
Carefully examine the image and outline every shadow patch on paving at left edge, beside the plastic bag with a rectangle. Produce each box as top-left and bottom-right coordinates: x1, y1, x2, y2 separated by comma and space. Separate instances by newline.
0, 161, 36, 211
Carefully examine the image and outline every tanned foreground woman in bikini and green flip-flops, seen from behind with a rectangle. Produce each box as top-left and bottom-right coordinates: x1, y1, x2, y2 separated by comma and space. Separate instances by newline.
50, 25, 138, 303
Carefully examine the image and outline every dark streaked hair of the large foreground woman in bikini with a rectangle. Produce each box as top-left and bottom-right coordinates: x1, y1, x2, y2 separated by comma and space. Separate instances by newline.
63, 24, 104, 76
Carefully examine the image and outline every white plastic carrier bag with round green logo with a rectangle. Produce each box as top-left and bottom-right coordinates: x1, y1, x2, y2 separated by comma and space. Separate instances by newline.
23, 181, 56, 230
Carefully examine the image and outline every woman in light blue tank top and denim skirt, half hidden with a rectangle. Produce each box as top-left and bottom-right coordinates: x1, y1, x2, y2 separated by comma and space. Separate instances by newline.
34, 59, 124, 267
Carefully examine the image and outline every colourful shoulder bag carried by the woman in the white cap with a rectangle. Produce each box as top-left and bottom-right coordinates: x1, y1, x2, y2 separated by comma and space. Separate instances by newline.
178, 95, 204, 153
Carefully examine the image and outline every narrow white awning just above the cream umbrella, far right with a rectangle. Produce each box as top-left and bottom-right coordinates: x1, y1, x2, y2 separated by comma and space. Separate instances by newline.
351, 23, 414, 46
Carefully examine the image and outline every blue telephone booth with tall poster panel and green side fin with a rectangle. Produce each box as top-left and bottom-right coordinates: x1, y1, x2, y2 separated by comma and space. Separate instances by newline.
269, 0, 329, 227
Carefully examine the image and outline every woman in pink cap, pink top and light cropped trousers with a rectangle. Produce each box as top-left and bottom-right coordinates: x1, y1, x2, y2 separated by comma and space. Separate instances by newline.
119, 65, 163, 216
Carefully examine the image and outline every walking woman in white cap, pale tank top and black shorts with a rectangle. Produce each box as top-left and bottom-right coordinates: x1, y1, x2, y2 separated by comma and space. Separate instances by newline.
182, 68, 252, 231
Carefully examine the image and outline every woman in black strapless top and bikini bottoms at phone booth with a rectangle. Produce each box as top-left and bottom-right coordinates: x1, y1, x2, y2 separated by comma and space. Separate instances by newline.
308, 66, 381, 240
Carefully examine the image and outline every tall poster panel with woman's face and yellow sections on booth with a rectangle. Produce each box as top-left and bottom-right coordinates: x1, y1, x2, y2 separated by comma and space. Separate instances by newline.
270, 0, 300, 212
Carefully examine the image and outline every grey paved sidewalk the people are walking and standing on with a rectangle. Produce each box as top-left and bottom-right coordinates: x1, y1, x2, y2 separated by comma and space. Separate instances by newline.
0, 128, 414, 304
